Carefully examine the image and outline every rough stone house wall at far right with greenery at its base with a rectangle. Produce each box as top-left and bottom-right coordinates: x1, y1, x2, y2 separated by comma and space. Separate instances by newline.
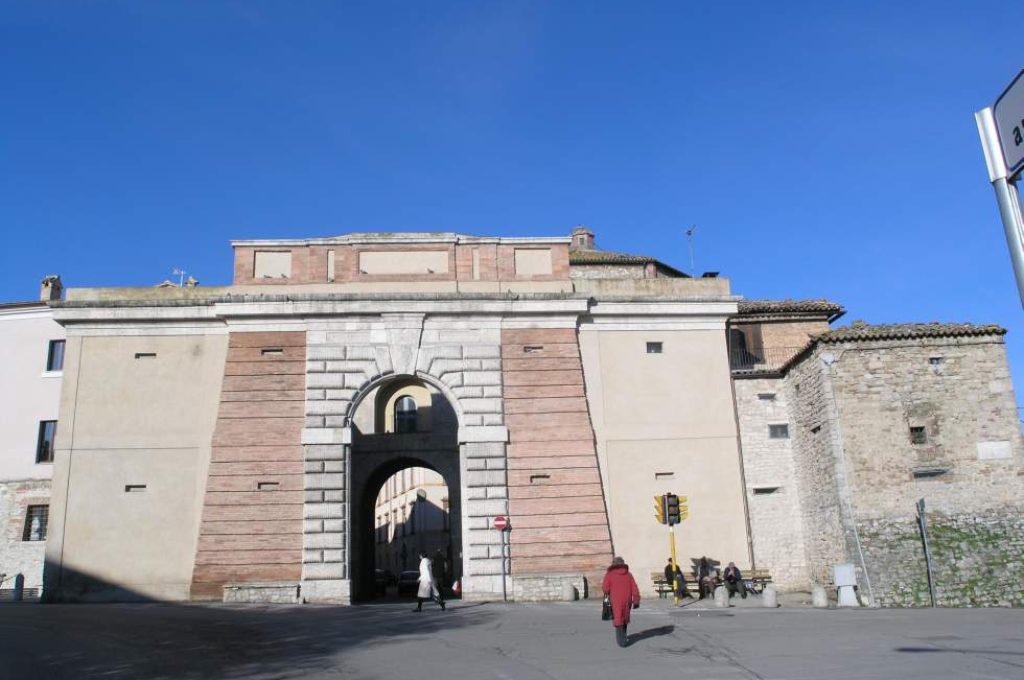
816, 336, 1024, 605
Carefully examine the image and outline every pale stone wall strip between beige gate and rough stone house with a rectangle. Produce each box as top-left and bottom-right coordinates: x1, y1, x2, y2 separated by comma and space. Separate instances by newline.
734, 378, 808, 590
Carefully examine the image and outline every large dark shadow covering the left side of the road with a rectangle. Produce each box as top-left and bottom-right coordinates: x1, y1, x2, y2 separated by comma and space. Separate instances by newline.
0, 565, 496, 680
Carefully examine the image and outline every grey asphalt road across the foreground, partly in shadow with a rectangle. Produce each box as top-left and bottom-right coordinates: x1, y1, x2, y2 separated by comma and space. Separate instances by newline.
0, 600, 1024, 680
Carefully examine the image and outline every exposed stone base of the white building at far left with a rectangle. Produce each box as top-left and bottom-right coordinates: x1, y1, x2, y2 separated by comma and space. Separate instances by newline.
0, 480, 50, 591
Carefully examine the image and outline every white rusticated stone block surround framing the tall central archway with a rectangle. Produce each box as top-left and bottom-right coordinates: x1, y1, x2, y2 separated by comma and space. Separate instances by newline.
302, 313, 508, 599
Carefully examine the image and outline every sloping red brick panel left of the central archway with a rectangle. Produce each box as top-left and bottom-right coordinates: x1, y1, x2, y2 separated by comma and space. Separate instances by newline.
191, 332, 305, 600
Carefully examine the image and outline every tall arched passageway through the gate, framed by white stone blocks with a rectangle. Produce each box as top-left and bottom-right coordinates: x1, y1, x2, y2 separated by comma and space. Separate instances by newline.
349, 377, 463, 601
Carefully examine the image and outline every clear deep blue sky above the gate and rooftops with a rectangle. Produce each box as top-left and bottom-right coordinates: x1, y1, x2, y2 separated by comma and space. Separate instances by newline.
0, 0, 1024, 389
